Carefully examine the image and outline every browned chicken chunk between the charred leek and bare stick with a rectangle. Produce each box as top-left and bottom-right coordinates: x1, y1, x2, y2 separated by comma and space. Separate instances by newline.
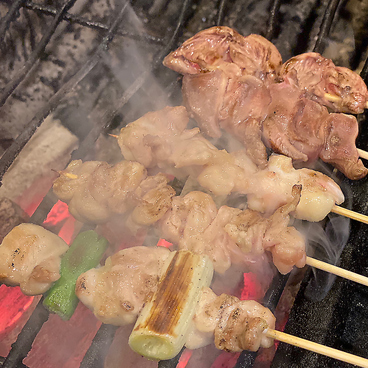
186, 288, 276, 352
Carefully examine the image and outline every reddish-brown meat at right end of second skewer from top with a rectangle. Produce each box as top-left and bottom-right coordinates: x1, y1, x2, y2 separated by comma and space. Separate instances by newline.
263, 82, 368, 180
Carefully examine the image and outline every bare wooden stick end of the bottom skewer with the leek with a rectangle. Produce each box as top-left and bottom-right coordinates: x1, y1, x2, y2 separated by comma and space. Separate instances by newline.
264, 329, 368, 368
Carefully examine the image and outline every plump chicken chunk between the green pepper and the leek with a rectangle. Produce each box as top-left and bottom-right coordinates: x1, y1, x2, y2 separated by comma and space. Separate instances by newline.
76, 246, 170, 326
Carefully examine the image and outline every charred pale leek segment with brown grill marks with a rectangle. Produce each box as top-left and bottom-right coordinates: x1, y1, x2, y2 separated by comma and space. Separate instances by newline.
129, 251, 213, 360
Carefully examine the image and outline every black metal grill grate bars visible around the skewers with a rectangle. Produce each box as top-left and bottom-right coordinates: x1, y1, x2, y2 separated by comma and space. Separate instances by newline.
0, 0, 368, 368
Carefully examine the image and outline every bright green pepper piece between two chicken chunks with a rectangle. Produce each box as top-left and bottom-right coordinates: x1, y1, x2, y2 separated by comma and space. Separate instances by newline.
43, 230, 108, 320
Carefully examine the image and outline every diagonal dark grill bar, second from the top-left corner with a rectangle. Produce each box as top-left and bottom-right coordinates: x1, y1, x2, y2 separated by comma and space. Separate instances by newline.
0, 0, 76, 107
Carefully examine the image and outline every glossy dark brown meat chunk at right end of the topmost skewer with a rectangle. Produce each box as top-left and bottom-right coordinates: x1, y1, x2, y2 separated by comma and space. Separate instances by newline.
280, 52, 368, 114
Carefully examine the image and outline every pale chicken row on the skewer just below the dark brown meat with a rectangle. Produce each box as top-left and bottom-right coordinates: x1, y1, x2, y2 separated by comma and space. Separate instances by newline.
118, 106, 349, 221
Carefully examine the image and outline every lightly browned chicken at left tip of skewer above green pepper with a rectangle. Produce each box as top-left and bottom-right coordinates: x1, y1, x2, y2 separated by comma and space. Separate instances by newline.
53, 160, 175, 227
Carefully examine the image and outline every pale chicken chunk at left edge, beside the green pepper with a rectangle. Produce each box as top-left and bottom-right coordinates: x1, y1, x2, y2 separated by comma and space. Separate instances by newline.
0, 224, 69, 295
